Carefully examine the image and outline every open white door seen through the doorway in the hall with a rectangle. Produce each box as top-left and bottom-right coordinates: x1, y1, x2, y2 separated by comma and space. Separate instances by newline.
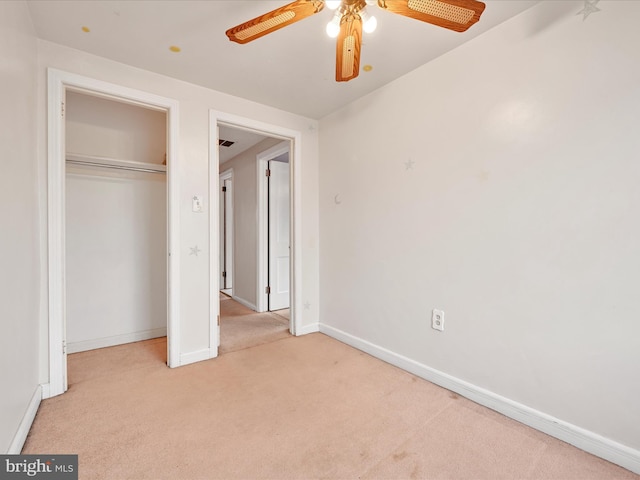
268, 158, 290, 311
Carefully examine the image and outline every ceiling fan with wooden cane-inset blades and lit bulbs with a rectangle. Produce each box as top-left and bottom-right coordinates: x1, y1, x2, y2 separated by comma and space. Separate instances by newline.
226, 0, 485, 82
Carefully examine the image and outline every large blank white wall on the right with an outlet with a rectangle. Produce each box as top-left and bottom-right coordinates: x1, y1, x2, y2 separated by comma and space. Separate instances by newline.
320, 1, 640, 465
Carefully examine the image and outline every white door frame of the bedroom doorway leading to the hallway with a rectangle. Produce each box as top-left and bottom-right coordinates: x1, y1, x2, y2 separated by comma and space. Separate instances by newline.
209, 110, 302, 338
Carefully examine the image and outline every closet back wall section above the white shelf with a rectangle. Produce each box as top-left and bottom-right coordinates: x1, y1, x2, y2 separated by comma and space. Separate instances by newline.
65, 92, 167, 165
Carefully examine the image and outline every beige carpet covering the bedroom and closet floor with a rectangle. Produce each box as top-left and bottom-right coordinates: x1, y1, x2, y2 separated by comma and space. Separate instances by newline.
23, 333, 640, 480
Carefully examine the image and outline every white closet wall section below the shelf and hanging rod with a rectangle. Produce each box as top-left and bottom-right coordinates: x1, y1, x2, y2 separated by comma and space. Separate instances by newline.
66, 166, 167, 353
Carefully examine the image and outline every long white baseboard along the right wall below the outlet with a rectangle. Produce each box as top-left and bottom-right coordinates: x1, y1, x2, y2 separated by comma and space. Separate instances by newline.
320, 323, 640, 474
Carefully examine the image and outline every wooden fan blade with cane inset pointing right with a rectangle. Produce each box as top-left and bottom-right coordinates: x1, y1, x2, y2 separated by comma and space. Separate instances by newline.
378, 0, 485, 32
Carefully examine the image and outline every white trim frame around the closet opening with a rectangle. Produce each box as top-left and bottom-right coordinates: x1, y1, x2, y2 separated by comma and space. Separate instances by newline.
43, 68, 180, 398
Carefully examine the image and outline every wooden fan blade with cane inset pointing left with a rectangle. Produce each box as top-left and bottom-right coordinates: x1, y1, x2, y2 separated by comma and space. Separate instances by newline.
226, 0, 324, 43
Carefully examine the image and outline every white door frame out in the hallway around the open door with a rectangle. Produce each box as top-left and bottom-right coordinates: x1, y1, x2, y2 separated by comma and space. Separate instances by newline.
256, 140, 291, 312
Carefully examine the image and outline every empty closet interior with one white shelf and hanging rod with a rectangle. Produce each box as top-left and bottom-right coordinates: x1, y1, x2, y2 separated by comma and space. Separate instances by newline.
65, 91, 167, 353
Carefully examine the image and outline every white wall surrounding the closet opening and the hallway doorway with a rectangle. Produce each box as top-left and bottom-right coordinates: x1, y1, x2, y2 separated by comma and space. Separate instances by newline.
38, 40, 319, 372
